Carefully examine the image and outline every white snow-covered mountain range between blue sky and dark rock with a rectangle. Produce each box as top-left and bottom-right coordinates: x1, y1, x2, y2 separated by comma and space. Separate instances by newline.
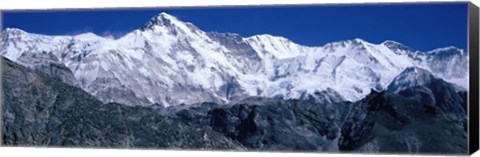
0, 13, 468, 106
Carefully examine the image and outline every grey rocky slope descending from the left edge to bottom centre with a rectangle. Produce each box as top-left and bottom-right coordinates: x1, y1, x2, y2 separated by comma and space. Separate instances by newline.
2, 59, 243, 150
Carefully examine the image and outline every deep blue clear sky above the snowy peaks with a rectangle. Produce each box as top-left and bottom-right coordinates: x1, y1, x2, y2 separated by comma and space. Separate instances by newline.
3, 2, 468, 51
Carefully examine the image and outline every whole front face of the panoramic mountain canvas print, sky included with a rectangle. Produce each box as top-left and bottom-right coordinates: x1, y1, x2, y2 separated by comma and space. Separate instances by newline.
0, 2, 469, 154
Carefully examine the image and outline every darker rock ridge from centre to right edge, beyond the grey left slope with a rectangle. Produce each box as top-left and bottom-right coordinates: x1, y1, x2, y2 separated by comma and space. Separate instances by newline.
169, 90, 468, 154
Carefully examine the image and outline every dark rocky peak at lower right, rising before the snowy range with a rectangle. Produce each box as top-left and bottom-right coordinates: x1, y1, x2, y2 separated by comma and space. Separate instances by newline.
339, 92, 468, 154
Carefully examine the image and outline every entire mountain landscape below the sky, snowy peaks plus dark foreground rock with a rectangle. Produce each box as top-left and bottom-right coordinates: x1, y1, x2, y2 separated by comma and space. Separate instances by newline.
0, 13, 468, 154
